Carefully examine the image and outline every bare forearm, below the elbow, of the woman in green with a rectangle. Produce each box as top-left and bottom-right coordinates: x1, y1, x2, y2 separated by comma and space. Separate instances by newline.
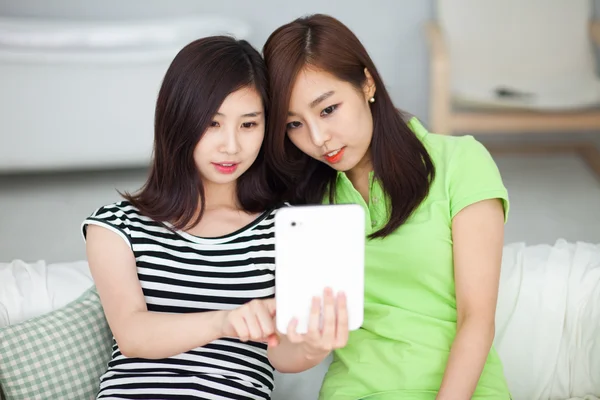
437, 317, 494, 400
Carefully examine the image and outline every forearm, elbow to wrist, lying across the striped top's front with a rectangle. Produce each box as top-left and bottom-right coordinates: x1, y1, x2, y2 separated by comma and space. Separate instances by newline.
115, 311, 226, 359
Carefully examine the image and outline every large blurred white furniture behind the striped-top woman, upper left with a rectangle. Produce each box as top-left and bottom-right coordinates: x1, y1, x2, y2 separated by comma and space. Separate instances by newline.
0, 14, 252, 173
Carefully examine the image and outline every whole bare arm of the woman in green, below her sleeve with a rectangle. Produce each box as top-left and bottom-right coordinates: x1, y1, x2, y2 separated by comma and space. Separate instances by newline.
437, 199, 504, 400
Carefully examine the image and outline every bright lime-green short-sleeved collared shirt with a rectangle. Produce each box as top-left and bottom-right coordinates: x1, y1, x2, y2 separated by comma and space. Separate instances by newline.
320, 118, 510, 400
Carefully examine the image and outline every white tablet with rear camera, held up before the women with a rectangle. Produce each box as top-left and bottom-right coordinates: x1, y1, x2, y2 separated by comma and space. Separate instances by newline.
275, 204, 365, 333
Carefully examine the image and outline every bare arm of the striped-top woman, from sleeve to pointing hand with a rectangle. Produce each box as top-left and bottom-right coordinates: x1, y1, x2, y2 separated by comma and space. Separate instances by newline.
86, 225, 274, 359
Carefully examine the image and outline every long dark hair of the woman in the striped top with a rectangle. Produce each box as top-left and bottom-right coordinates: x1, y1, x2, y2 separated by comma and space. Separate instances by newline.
122, 36, 279, 229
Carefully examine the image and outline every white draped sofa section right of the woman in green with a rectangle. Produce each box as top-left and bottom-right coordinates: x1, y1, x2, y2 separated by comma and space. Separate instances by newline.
495, 240, 600, 400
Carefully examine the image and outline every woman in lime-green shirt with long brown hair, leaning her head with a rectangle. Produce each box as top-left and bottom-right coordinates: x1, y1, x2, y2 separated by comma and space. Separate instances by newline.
263, 15, 510, 400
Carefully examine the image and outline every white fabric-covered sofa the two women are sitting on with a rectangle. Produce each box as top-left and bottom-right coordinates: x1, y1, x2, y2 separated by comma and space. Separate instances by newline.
0, 240, 600, 400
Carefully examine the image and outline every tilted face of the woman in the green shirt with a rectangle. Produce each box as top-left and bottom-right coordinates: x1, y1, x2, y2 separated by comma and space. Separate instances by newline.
287, 68, 375, 172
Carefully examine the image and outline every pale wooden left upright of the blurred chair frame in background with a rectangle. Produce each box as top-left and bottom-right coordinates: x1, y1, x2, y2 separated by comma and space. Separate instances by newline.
425, 21, 452, 134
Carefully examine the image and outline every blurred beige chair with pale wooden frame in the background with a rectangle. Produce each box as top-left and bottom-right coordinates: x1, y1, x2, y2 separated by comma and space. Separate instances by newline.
426, 0, 600, 177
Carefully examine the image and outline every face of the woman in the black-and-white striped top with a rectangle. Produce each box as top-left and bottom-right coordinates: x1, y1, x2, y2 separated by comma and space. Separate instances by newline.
194, 87, 265, 184
